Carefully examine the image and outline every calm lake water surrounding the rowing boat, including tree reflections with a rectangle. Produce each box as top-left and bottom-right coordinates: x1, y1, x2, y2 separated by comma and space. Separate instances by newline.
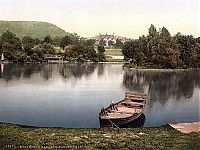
0, 63, 200, 128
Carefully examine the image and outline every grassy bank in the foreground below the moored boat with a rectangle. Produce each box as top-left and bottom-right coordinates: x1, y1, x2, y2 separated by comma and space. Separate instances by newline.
0, 123, 200, 150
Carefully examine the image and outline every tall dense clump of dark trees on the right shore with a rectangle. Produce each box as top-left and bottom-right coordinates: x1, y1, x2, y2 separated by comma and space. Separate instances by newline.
122, 25, 200, 68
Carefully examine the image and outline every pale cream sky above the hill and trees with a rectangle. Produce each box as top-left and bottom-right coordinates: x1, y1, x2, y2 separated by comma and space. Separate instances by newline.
0, 0, 200, 38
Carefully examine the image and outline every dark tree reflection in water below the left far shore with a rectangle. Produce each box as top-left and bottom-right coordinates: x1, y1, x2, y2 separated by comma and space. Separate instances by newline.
0, 64, 97, 81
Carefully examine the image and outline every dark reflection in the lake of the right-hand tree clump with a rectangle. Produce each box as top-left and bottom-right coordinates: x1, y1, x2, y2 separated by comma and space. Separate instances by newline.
123, 70, 200, 104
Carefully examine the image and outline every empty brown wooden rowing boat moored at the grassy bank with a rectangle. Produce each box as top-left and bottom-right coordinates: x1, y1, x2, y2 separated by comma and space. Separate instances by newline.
99, 92, 147, 127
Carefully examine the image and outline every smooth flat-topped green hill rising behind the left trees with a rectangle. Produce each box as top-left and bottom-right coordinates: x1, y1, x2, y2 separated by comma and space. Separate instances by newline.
0, 21, 67, 39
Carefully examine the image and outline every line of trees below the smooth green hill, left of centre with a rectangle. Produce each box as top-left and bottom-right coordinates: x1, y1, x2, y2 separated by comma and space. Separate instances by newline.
0, 31, 105, 62
